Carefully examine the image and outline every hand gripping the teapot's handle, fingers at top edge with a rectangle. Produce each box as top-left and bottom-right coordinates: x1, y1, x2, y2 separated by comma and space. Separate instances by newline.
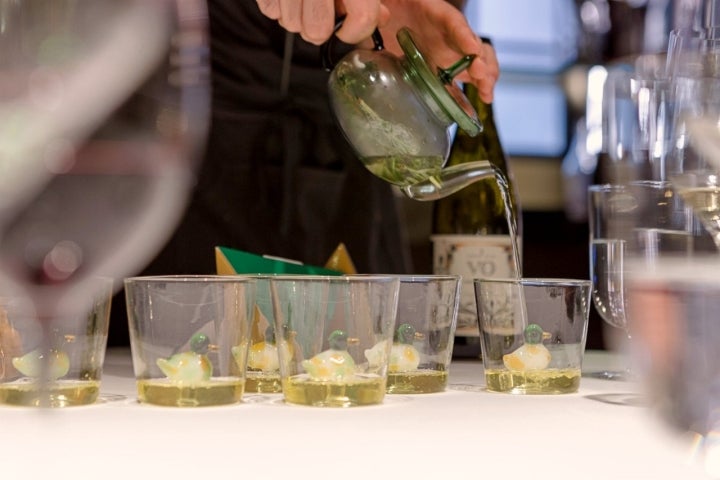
258, 0, 389, 45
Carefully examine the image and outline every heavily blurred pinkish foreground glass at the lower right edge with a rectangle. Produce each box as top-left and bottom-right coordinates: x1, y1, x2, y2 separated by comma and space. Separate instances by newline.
628, 254, 720, 478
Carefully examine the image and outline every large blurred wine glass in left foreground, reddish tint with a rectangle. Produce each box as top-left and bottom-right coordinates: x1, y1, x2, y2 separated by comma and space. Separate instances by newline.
0, 0, 209, 404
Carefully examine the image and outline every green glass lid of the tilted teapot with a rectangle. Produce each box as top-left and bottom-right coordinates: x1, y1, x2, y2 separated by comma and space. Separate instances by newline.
397, 27, 482, 136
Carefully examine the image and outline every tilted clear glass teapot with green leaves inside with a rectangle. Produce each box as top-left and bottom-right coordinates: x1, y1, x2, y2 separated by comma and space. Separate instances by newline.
322, 20, 495, 200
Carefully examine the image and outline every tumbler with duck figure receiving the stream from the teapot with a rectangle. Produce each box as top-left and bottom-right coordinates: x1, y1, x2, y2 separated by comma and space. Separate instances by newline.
473, 278, 590, 394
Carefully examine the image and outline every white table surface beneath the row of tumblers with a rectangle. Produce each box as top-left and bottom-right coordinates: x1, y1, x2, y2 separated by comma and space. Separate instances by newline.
0, 349, 707, 480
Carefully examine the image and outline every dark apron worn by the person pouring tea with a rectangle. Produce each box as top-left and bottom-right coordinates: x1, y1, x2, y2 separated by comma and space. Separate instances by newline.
109, 0, 411, 344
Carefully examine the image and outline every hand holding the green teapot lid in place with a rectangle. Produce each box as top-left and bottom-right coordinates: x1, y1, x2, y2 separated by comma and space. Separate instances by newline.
380, 0, 500, 103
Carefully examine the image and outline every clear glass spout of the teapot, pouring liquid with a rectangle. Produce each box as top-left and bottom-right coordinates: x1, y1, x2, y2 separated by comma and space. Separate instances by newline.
400, 160, 495, 201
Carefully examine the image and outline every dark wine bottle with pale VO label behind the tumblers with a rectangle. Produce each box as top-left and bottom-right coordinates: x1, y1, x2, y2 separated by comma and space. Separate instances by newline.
431, 83, 522, 358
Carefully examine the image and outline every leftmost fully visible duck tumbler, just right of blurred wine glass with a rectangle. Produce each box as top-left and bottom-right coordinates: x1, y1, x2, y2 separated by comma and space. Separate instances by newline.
124, 275, 255, 407
